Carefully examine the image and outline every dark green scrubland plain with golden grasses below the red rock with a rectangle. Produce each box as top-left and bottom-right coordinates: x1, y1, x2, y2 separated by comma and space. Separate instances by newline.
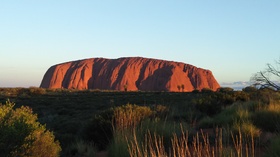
0, 87, 280, 157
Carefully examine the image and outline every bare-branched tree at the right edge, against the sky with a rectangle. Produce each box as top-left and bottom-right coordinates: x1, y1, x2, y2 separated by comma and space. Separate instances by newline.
251, 58, 280, 90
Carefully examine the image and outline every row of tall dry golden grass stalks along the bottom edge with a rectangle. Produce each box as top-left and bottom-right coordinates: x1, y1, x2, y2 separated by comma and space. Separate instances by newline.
126, 128, 260, 157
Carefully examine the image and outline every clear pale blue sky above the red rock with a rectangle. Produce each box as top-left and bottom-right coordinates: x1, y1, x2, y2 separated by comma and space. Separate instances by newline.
0, 0, 280, 87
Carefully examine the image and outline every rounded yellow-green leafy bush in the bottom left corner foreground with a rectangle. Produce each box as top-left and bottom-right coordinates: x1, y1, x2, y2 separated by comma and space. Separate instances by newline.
0, 101, 61, 157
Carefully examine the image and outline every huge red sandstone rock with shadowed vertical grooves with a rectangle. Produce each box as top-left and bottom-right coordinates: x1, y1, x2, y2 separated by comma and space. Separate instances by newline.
40, 57, 220, 91
